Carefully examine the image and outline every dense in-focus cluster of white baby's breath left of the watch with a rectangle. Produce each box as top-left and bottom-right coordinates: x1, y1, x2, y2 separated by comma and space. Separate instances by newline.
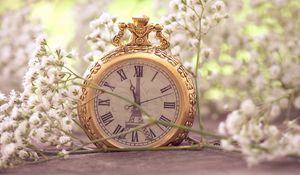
0, 35, 80, 167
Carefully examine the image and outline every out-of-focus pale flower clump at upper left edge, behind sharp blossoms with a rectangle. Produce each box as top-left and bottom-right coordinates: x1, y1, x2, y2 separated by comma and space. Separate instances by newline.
0, 7, 41, 93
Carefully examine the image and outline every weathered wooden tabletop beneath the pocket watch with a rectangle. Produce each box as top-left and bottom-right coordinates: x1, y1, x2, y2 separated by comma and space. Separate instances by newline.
0, 119, 300, 175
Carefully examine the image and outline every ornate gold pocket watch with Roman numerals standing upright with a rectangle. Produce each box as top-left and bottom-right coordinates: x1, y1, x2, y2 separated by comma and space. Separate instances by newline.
78, 16, 195, 148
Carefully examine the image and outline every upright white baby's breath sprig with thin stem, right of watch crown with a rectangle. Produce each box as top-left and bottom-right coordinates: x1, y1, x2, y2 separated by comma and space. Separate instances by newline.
164, 0, 227, 130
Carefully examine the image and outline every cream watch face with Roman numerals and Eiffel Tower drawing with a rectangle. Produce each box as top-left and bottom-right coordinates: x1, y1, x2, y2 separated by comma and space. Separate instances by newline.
94, 58, 181, 146
